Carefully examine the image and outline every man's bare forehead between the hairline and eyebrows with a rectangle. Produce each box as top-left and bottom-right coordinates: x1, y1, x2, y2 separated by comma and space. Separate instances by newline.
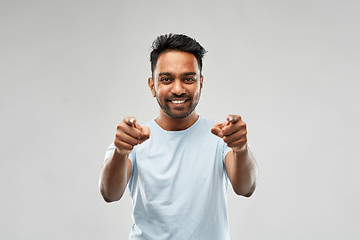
155, 51, 200, 75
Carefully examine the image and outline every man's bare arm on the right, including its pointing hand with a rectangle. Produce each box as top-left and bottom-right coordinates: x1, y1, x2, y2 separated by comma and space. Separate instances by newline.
211, 115, 258, 197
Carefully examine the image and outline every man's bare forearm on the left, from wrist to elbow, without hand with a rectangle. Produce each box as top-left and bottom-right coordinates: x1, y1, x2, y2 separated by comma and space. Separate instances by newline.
100, 150, 128, 202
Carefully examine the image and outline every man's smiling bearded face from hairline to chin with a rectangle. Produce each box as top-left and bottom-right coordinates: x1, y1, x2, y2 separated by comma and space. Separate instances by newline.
149, 51, 203, 119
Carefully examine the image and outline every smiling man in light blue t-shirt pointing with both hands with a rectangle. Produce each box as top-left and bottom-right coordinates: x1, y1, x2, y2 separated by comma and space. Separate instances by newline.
100, 34, 257, 240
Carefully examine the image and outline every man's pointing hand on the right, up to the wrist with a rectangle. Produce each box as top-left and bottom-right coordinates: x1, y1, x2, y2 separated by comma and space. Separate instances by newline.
211, 115, 247, 152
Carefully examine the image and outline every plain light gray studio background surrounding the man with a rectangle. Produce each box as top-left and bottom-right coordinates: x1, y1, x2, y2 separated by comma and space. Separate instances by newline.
0, 0, 360, 240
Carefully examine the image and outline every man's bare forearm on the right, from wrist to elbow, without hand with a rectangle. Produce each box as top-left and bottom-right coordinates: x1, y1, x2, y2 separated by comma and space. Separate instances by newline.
229, 145, 258, 197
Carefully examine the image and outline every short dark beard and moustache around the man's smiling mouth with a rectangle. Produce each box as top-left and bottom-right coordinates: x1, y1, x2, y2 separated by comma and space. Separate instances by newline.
155, 91, 200, 119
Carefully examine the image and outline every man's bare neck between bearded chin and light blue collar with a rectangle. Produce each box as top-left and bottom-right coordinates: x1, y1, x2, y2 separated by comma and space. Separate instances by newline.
155, 110, 199, 131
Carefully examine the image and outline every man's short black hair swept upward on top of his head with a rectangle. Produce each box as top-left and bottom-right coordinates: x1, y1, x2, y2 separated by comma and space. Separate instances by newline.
150, 33, 207, 74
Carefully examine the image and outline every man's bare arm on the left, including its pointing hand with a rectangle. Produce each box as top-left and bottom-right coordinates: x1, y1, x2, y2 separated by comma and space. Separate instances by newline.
99, 118, 150, 202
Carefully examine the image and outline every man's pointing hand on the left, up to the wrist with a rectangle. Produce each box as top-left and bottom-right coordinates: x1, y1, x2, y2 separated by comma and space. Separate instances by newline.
114, 117, 150, 155
